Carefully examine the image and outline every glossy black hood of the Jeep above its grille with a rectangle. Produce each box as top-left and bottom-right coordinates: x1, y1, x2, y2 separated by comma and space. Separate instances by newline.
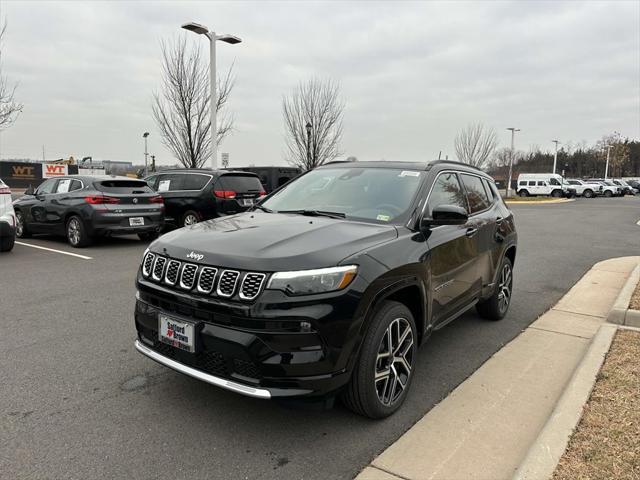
150, 211, 398, 272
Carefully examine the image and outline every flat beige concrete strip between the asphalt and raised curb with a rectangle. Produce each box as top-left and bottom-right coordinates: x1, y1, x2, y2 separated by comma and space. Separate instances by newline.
356, 257, 640, 480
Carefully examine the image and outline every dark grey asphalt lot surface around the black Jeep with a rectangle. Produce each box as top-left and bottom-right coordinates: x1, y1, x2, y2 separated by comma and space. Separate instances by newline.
0, 197, 640, 479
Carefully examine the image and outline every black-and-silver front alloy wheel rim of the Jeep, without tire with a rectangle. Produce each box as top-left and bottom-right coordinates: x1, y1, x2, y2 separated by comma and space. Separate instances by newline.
374, 318, 415, 406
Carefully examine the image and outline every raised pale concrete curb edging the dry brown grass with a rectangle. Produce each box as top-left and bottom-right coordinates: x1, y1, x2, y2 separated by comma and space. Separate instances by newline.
513, 324, 617, 480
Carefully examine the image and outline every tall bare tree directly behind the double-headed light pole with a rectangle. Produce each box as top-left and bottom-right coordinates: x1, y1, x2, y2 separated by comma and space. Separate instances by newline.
153, 38, 235, 168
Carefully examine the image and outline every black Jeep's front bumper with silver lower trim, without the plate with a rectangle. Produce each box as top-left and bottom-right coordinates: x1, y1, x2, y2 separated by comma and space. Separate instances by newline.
135, 276, 368, 398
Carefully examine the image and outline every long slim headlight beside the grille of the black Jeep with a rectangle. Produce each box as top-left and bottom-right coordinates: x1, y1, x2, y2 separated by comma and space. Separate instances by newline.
267, 265, 358, 295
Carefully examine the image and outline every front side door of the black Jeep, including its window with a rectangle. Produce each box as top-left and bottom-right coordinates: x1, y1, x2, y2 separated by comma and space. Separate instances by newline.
427, 172, 479, 325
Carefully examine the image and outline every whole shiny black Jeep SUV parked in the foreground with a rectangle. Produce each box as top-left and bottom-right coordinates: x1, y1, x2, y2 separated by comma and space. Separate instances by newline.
135, 161, 516, 418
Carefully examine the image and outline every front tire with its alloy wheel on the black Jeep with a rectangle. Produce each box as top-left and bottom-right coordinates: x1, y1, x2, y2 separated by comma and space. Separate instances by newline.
342, 301, 418, 418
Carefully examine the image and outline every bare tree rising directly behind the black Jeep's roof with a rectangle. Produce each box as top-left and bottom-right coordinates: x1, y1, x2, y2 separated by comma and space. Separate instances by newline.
282, 79, 344, 170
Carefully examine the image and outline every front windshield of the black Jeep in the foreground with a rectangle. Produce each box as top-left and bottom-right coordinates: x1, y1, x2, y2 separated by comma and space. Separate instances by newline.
261, 167, 425, 222
